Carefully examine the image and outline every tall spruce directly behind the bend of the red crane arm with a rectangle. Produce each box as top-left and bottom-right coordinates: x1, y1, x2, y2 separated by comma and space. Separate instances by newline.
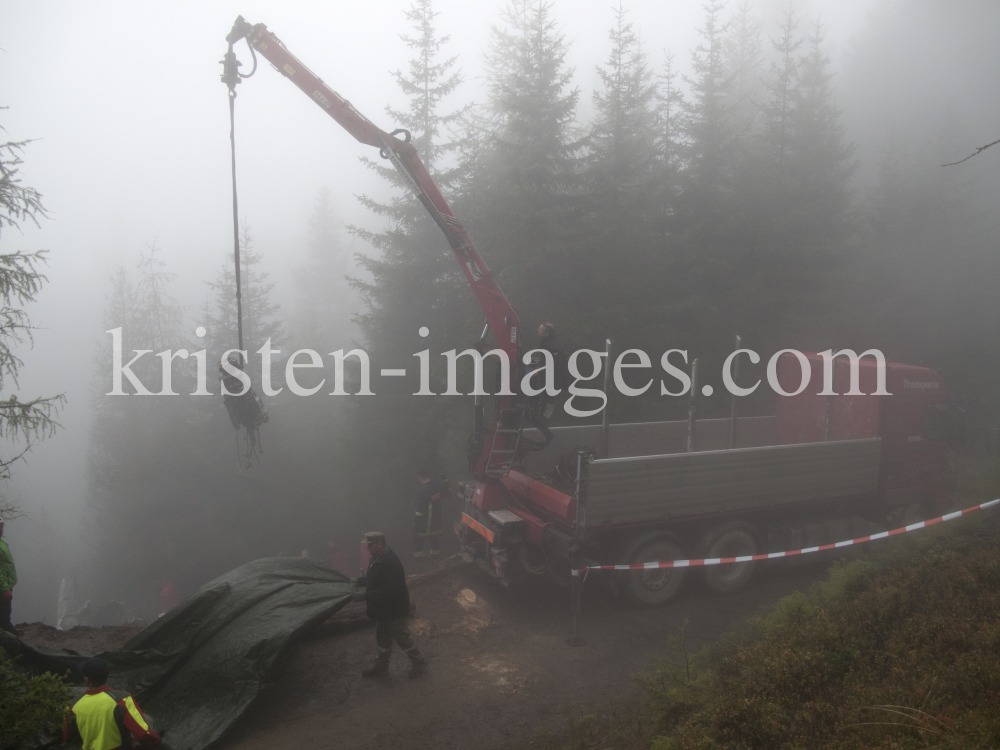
345, 0, 470, 496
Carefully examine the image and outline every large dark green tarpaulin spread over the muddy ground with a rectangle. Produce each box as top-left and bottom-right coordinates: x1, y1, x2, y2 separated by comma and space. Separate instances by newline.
0, 557, 356, 750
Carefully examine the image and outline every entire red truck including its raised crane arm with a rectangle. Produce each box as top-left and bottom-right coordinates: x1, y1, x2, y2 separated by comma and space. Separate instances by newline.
223, 17, 952, 606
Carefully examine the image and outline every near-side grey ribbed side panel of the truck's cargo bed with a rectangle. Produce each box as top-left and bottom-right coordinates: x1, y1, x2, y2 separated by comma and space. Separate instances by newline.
586, 438, 880, 528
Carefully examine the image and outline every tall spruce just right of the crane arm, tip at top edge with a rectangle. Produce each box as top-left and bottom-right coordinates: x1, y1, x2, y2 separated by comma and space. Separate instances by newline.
473, 0, 583, 330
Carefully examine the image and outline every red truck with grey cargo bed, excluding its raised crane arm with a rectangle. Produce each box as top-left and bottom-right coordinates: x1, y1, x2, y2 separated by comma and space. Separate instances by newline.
488, 354, 957, 605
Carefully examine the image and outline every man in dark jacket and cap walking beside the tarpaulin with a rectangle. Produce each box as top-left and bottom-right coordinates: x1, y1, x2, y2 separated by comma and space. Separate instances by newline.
354, 531, 427, 677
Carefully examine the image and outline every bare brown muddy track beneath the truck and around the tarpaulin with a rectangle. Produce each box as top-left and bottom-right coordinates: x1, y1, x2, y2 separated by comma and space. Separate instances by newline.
19, 562, 826, 750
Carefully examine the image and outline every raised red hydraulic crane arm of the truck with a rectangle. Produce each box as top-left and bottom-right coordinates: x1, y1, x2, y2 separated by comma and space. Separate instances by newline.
222, 16, 520, 478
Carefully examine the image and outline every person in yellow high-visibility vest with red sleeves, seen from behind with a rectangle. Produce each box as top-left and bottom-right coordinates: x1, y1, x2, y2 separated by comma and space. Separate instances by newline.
63, 658, 160, 750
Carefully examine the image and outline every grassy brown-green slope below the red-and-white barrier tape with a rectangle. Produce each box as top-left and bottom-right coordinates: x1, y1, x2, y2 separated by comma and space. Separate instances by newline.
534, 482, 1000, 750
